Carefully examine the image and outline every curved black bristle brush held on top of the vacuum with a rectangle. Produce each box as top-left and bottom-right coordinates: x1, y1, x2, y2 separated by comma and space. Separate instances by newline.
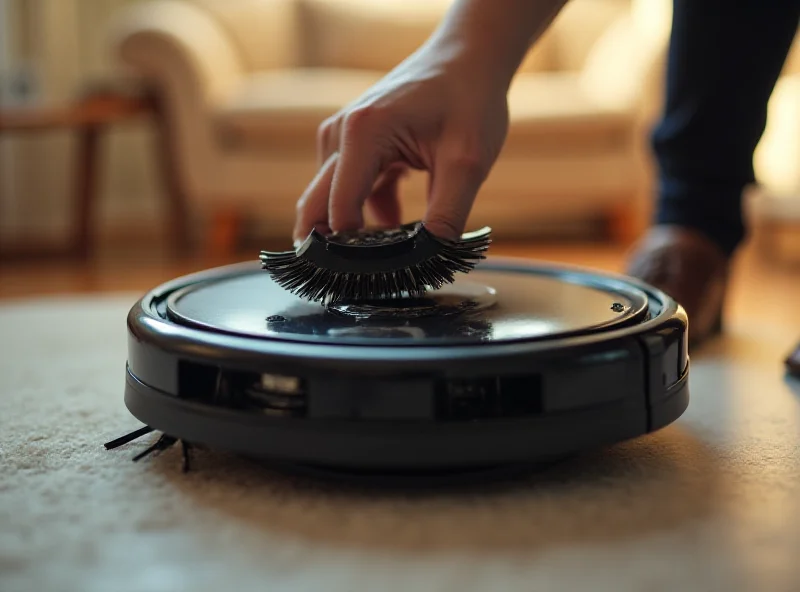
260, 226, 491, 303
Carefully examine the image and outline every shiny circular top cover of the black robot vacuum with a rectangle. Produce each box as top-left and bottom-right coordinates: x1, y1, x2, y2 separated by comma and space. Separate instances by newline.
164, 266, 648, 346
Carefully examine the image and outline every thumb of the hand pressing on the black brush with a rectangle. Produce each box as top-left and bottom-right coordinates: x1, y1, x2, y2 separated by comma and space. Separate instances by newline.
423, 151, 486, 240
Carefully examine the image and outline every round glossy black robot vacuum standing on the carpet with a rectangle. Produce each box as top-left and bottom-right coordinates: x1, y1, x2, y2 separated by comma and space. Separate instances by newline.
114, 257, 689, 476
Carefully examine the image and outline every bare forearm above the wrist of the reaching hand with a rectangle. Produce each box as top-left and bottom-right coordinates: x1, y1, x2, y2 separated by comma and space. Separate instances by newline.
431, 0, 568, 84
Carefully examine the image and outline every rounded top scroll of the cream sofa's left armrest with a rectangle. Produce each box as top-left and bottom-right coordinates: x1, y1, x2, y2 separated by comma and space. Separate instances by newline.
111, 0, 242, 106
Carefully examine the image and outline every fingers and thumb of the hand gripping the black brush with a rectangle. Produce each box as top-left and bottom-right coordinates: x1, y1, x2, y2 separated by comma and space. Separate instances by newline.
306, 106, 490, 240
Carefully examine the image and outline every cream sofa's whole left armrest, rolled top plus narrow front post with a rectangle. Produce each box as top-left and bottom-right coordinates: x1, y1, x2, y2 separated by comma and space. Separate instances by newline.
110, 0, 243, 201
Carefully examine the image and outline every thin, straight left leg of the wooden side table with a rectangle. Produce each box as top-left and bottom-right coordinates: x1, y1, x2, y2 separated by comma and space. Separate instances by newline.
72, 125, 100, 260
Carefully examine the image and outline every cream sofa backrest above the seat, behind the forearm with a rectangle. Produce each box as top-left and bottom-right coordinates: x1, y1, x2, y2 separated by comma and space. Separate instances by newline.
190, 0, 631, 72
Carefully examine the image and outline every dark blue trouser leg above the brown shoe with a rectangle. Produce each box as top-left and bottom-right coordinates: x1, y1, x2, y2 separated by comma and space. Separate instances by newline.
652, 0, 800, 255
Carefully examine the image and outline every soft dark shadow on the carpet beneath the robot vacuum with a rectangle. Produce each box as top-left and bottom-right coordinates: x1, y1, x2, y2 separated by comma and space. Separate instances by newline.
126, 425, 720, 553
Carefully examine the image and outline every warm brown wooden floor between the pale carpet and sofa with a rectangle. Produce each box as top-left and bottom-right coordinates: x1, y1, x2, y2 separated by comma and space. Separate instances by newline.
0, 238, 800, 346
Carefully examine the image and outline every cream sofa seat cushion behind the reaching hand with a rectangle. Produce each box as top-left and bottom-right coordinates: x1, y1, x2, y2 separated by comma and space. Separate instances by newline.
215, 68, 632, 154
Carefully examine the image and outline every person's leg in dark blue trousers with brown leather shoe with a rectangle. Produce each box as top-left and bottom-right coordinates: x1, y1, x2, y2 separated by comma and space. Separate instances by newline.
628, 0, 800, 343
